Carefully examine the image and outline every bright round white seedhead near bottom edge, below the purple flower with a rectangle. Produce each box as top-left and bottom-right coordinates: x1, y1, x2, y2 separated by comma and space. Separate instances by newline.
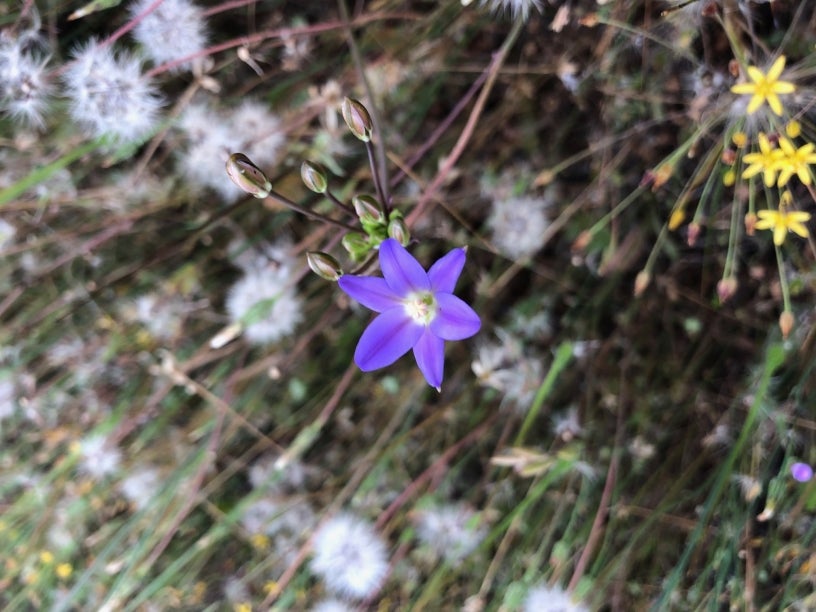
310, 514, 388, 599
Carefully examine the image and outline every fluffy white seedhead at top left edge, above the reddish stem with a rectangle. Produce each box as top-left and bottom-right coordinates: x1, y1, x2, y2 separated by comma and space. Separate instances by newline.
130, 0, 207, 70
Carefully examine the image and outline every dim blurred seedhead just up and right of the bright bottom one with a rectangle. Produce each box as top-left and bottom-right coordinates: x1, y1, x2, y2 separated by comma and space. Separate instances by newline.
416, 504, 486, 567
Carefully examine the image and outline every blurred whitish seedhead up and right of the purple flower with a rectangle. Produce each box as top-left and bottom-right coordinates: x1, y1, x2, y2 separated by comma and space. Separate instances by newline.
487, 197, 550, 259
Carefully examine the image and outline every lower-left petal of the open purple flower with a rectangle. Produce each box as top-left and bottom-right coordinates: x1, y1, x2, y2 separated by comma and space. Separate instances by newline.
354, 307, 425, 372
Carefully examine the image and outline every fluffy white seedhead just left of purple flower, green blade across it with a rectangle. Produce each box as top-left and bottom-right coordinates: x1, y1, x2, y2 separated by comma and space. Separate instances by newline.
227, 251, 303, 344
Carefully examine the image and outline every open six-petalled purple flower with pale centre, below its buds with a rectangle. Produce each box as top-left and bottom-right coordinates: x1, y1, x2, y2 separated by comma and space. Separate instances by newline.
337, 238, 482, 390
